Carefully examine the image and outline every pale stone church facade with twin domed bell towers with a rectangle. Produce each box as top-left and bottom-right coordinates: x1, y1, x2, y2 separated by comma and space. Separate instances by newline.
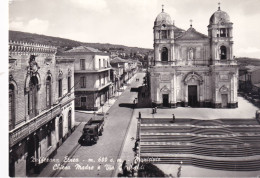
149, 7, 238, 108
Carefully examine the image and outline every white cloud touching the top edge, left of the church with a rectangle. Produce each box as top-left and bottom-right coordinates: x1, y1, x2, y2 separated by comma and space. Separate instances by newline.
70, 0, 109, 13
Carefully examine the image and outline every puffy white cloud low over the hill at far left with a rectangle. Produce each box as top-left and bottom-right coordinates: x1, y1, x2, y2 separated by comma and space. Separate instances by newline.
9, 18, 49, 34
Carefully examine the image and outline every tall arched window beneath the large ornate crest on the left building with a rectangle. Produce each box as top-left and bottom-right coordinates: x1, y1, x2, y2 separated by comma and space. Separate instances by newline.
28, 76, 38, 117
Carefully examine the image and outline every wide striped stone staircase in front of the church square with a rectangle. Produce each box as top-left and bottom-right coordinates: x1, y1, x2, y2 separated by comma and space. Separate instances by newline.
140, 118, 260, 171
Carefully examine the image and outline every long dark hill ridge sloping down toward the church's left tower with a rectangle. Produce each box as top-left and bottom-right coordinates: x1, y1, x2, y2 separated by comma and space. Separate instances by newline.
9, 30, 152, 54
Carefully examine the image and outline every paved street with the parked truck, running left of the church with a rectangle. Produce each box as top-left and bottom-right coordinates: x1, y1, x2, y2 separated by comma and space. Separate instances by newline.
39, 73, 144, 177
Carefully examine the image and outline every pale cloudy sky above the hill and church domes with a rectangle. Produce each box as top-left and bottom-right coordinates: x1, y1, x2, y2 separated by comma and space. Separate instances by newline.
8, 0, 260, 58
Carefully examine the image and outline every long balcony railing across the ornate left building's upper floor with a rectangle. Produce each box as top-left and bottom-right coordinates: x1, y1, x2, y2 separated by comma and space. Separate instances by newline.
9, 104, 61, 146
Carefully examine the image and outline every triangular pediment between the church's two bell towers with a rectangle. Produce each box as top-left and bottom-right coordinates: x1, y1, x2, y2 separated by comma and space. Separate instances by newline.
175, 28, 208, 40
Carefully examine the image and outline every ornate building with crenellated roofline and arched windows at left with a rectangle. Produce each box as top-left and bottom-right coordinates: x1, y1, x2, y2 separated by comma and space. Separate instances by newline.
9, 41, 74, 177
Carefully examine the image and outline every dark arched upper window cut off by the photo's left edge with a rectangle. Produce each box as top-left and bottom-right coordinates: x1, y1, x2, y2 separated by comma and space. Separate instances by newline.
9, 84, 15, 130
